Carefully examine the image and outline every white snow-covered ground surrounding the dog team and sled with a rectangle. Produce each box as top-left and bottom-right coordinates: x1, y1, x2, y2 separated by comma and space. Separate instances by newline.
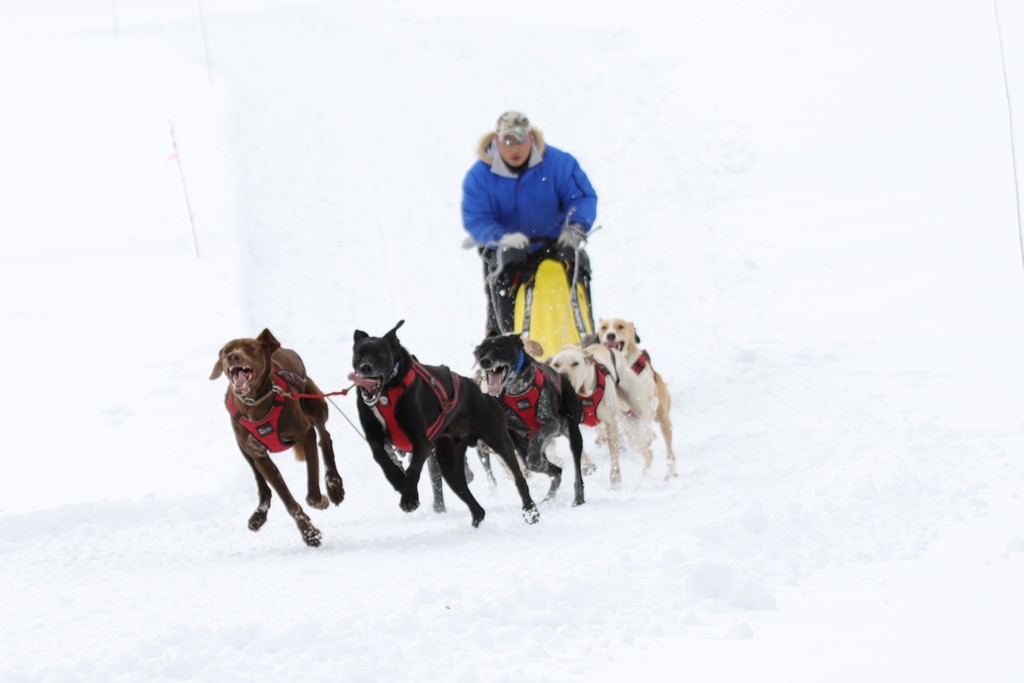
0, 0, 1024, 683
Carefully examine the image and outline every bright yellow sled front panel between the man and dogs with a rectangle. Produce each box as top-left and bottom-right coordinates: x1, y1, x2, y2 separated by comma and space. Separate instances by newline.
515, 258, 594, 355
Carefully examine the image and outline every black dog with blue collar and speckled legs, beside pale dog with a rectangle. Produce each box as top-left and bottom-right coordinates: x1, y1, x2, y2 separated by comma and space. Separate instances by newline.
473, 335, 584, 505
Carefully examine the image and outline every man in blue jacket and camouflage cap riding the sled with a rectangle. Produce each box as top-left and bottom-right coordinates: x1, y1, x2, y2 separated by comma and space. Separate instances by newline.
462, 112, 597, 336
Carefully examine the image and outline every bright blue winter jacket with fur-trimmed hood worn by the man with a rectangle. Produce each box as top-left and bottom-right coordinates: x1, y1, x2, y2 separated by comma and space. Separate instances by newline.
462, 129, 597, 248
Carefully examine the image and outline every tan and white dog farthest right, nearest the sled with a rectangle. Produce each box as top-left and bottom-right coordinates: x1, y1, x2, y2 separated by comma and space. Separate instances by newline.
597, 317, 676, 478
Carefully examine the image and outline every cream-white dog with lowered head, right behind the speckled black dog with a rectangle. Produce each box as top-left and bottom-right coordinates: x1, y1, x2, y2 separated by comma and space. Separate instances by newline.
545, 344, 625, 488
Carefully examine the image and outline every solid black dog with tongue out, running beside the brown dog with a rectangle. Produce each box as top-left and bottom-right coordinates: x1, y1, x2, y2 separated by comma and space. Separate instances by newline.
348, 321, 539, 526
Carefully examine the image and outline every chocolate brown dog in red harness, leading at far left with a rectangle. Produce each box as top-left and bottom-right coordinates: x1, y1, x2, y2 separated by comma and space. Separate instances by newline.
210, 330, 345, 546
